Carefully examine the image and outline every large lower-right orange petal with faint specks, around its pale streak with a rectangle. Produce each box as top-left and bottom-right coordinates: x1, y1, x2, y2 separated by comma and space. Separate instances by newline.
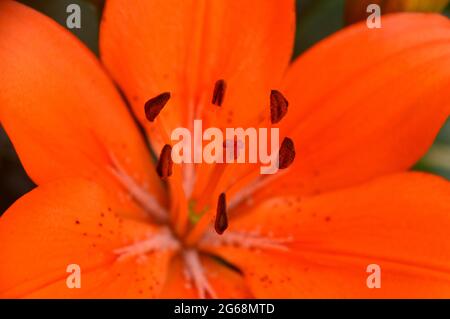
202, 173, 450, 298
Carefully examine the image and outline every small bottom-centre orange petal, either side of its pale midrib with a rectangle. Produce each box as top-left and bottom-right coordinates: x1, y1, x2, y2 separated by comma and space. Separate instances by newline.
158, 257, 251, 299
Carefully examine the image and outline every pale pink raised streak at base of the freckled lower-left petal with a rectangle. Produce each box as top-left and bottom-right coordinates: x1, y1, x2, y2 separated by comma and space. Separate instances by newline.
113, 228, 180, 261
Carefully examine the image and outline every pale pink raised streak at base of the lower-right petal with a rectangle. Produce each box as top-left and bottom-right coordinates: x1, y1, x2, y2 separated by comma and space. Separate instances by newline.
200, 231, 294, 251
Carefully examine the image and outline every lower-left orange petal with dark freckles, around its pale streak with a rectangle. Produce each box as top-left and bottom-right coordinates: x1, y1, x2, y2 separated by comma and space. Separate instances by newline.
0, 179, 176, 298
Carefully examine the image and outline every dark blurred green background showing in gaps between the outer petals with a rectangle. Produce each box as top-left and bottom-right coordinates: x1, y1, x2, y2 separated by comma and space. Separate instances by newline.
0, 0, 450, 215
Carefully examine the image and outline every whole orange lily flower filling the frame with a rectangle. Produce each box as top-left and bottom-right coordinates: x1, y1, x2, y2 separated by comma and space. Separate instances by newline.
0, 0, 450, 298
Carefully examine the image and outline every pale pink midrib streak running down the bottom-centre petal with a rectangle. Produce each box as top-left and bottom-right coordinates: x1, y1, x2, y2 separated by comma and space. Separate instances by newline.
183, 249, 217, 299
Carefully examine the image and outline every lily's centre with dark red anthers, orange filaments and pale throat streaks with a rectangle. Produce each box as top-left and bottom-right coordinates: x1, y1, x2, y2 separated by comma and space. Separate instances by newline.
110, 80, 295, 297
